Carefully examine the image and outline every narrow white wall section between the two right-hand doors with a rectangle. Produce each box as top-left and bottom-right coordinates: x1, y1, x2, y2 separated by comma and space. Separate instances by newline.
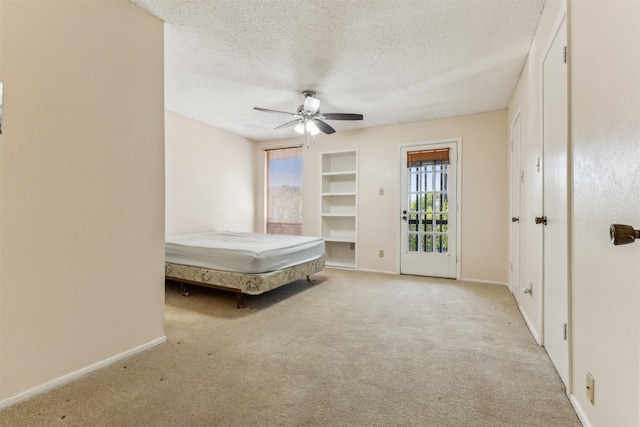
508, 0, 564, 342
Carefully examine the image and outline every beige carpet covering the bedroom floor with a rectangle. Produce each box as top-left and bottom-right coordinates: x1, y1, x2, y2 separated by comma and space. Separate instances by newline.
0, 269, 580, 427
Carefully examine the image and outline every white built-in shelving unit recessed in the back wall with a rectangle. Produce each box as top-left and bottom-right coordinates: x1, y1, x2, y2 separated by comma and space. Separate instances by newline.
320, 150, 358, 268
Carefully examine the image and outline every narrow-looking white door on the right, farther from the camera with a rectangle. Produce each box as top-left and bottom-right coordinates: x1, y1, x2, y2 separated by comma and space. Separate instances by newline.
509, 114, 522, 302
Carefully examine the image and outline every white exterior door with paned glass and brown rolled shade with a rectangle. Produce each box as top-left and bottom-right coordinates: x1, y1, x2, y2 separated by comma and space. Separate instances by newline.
400, 142, 458, 278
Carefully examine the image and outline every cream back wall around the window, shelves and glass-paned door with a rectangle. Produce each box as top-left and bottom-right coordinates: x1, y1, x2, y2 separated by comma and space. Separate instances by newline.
256, 110, 509, 283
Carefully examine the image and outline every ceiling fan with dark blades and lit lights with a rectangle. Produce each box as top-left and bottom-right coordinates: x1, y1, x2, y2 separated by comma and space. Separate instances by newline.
253, 90, 363, 136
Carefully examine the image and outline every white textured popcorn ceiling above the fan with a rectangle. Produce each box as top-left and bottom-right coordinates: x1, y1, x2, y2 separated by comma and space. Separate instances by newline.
131, 0, 545, 140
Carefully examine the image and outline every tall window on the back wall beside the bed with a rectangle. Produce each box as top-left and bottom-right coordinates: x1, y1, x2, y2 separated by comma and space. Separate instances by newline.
266, 147, 302, 236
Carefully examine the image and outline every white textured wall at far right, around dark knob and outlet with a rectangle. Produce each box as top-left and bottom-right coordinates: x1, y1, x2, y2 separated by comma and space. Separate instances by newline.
569, 0, 640, 426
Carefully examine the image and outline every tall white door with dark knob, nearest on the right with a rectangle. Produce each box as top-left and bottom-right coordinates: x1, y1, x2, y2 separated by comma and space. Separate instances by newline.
542, 17, 570, 385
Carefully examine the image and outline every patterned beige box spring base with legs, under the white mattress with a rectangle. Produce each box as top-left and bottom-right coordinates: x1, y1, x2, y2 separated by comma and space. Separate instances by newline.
164, 255, 325, 308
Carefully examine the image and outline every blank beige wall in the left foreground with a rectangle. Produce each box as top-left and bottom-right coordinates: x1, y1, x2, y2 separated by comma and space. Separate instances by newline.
0, 1, 164, 406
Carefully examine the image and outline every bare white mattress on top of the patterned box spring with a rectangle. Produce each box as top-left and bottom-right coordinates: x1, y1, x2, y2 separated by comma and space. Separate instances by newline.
165, 231, 324, 274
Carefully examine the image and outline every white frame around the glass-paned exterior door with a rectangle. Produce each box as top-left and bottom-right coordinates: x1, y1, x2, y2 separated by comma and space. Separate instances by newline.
396, 137, 462, 280
